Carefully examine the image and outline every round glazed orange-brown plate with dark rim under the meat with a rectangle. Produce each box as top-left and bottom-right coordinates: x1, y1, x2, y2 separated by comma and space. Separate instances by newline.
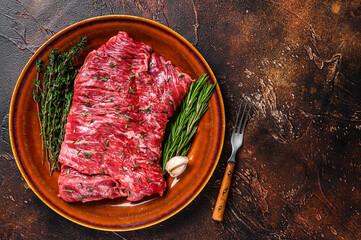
10, 16, 225, 231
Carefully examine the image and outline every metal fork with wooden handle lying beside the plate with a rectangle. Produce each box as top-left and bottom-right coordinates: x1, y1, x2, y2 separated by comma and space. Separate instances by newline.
212, 101, 252, 221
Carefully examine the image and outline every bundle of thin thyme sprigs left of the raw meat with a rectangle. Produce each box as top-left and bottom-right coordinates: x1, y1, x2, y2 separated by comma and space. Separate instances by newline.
33, 37, 86, 175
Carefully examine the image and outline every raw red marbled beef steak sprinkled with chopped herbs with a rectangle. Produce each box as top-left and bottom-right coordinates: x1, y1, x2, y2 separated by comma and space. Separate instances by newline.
58, 32, 193, 202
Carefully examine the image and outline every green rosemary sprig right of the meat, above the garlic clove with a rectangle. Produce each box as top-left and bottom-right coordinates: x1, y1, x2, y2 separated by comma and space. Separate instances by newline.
163, 74, 217, 172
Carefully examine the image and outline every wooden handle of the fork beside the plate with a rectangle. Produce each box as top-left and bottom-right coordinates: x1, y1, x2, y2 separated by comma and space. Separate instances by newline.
212, 162, 236, 221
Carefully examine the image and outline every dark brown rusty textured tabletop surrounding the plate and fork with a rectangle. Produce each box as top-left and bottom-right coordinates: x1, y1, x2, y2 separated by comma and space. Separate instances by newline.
0, 0, 361, 239
